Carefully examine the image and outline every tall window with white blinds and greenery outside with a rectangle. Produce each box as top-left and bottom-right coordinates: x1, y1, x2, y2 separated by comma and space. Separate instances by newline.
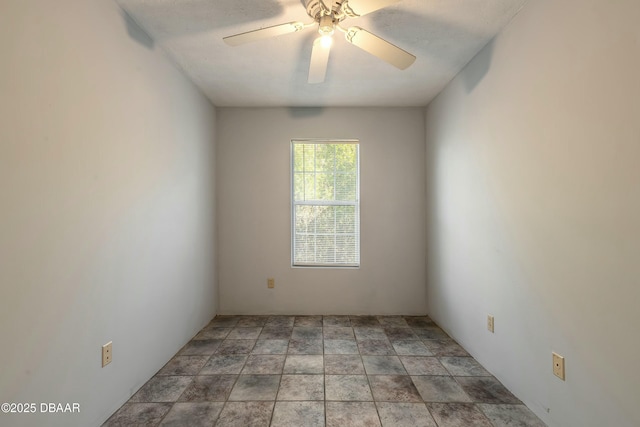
291, 140, 360, 267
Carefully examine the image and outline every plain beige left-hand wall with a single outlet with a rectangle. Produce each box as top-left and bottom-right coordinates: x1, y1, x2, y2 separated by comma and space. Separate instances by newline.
0, 0, 217, 427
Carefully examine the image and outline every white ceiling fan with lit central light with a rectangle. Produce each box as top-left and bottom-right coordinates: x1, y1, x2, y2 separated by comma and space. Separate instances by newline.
223, 0, 416, 83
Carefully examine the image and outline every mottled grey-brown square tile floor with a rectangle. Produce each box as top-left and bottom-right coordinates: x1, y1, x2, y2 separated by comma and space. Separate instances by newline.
104, 316, 544, 427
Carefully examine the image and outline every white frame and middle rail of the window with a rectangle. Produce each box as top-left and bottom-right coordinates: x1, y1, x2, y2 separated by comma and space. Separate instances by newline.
290, 138, 361, 268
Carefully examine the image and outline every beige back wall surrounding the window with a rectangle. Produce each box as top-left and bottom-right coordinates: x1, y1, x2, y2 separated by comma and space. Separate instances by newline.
217, 108, 426, 314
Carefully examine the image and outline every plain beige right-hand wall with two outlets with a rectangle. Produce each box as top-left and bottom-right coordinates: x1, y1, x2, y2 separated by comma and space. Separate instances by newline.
426, 0, 640, 427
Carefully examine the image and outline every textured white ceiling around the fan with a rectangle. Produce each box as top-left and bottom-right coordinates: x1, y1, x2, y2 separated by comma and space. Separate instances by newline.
116, 0, 527, 107
